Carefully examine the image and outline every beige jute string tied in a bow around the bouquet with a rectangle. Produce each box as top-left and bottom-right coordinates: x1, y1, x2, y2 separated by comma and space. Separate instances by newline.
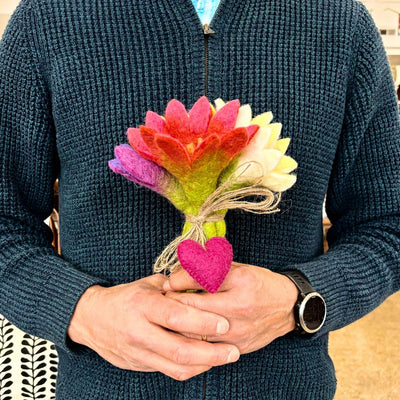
154, 161, 281, 273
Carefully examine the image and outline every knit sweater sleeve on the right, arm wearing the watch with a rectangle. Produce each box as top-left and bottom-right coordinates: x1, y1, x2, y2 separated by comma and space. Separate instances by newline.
292, 5, 400, 337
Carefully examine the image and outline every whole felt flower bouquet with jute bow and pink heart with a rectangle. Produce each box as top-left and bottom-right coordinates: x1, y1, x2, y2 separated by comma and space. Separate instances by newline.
109, 97, 297, 293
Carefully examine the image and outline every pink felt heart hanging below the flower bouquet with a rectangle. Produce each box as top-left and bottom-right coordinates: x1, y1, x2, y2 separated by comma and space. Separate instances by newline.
177, 237, 233, 293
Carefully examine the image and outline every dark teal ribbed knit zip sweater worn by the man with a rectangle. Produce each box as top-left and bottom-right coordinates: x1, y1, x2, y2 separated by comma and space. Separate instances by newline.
0, 0, 400, 400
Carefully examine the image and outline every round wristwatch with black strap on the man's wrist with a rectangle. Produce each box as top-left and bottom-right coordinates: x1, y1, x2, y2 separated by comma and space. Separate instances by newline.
280, 271, 326, 334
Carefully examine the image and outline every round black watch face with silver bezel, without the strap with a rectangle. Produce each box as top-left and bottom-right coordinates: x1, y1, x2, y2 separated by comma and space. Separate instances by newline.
300, 293, 326, 333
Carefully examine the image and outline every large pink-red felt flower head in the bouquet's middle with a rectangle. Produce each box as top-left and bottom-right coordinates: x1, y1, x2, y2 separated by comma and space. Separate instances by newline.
127, 97, 259, 189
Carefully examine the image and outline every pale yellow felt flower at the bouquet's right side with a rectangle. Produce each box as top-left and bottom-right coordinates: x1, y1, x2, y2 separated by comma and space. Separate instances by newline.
215, 99, 297, 192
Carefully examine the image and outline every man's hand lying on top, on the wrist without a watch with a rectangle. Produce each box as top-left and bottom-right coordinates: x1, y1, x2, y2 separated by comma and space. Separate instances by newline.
68, 274, 239, 380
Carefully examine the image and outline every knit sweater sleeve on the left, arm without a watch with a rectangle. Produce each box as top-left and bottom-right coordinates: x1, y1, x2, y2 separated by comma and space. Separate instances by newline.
0, 2, 108, 350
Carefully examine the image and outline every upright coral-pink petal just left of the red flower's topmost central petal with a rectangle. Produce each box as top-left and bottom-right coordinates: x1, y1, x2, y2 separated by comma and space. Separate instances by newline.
164, 99, 192, 145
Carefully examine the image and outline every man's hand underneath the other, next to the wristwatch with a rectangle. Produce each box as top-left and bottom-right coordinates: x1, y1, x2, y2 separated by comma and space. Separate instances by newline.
164, 263, 298, 354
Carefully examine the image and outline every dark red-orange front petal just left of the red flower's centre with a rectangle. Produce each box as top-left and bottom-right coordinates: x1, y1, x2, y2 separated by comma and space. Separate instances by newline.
155, 135, 190, 173
